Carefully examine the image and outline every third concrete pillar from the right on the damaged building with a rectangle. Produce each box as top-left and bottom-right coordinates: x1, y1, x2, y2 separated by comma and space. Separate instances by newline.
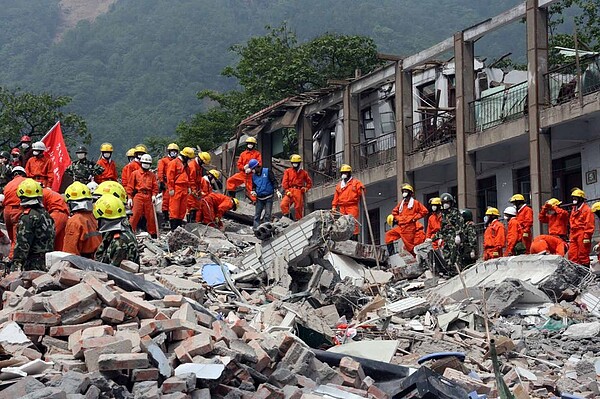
395, 62, 414, 198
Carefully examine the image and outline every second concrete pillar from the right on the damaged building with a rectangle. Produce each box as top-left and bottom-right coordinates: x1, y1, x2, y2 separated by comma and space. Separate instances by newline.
454, 32, 477, 220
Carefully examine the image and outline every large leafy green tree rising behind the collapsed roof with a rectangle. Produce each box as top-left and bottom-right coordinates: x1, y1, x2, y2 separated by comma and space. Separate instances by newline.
177, 23, 382, 148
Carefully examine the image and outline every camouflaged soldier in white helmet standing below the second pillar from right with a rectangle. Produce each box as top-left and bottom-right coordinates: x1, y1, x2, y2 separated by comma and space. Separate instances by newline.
434, 193, 465, 275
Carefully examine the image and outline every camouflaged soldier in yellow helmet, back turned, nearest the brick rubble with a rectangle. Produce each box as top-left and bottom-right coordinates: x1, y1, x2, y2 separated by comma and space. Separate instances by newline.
94, 194, 140, 267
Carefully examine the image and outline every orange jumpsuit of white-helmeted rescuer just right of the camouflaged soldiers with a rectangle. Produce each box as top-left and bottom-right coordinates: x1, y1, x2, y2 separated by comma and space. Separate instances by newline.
127, 169, 158, 235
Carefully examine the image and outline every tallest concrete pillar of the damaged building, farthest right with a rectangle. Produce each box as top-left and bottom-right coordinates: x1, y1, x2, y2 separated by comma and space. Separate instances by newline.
526, 0, 552, 235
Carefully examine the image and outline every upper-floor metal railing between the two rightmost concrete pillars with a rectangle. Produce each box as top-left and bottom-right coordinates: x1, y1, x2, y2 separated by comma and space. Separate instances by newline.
468, 82, 528, 133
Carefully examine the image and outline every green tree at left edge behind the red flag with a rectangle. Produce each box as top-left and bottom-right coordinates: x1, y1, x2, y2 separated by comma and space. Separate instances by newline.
0, 87, 91, 147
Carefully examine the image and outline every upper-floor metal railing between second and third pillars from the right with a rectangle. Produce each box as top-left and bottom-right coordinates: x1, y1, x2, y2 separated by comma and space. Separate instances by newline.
406, 111, 456, 155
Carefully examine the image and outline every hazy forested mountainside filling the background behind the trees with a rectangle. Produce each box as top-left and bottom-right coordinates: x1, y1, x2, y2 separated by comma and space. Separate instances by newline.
0, 0, 525, 152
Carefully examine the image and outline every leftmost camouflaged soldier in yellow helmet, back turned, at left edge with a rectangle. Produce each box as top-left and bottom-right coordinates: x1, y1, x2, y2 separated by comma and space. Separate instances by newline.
13, 179, 56, 270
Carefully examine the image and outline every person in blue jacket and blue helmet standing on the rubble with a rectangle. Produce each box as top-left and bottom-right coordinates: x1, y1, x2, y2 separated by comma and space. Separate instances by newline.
248, 159, 282, 229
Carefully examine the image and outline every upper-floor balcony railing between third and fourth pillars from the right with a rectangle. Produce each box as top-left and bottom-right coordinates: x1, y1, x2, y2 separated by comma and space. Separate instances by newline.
352, 132, 396, 170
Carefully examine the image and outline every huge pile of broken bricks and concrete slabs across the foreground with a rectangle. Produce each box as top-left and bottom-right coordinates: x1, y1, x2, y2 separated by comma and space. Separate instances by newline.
0, 211, 600, 399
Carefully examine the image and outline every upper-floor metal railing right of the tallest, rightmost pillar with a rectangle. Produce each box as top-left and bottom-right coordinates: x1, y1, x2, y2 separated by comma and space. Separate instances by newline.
545, 55, 600, 107
